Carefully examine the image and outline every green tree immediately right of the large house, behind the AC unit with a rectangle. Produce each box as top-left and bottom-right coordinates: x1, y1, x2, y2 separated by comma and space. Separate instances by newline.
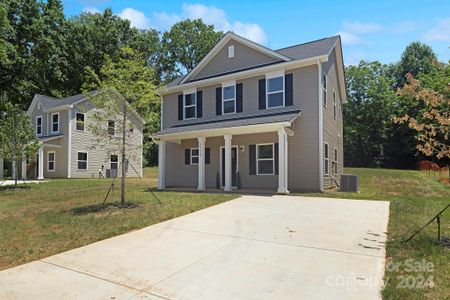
343, 61, 395, 167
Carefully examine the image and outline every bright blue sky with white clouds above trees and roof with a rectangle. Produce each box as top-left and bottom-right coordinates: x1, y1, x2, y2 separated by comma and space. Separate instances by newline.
63, 0, 450, 64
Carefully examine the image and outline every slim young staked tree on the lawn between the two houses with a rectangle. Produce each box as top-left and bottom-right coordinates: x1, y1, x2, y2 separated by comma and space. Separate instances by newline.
83, 48, 160, 205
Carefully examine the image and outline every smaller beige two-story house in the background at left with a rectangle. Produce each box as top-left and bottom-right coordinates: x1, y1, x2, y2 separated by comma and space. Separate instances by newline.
21, 91, 143, 179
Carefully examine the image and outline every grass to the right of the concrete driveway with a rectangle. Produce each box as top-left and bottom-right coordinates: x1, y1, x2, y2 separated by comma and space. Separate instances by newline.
302, 168, 450, 299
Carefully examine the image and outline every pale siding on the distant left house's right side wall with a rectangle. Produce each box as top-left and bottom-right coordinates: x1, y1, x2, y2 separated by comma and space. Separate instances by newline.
71, 102, 142, 178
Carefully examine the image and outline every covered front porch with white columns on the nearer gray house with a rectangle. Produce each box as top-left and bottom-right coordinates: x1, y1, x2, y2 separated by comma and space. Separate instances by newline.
156, 113, 298, 194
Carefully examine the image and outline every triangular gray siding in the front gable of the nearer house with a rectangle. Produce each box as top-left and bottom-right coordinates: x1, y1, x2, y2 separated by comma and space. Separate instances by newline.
192, 40, 280, 80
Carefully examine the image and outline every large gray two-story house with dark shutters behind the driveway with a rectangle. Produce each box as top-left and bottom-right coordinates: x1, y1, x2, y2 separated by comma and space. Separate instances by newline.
154, 32, 347, 193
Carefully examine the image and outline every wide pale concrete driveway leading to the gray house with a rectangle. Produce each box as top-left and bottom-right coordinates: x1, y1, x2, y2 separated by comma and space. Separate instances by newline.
0, 196, 389, 299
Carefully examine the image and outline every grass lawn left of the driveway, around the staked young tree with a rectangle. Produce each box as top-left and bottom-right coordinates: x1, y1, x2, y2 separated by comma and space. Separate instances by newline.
0, 168, 237, 269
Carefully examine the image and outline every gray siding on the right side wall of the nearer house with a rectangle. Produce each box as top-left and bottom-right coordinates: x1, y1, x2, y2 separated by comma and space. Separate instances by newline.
323, 51, 344, 188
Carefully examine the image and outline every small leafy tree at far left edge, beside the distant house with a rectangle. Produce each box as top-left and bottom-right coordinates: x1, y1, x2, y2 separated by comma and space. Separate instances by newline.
0, 96, 39, 187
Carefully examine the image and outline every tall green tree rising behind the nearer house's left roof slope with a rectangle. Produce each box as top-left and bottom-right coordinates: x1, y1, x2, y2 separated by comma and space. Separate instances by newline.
157, 19, 223, 82
